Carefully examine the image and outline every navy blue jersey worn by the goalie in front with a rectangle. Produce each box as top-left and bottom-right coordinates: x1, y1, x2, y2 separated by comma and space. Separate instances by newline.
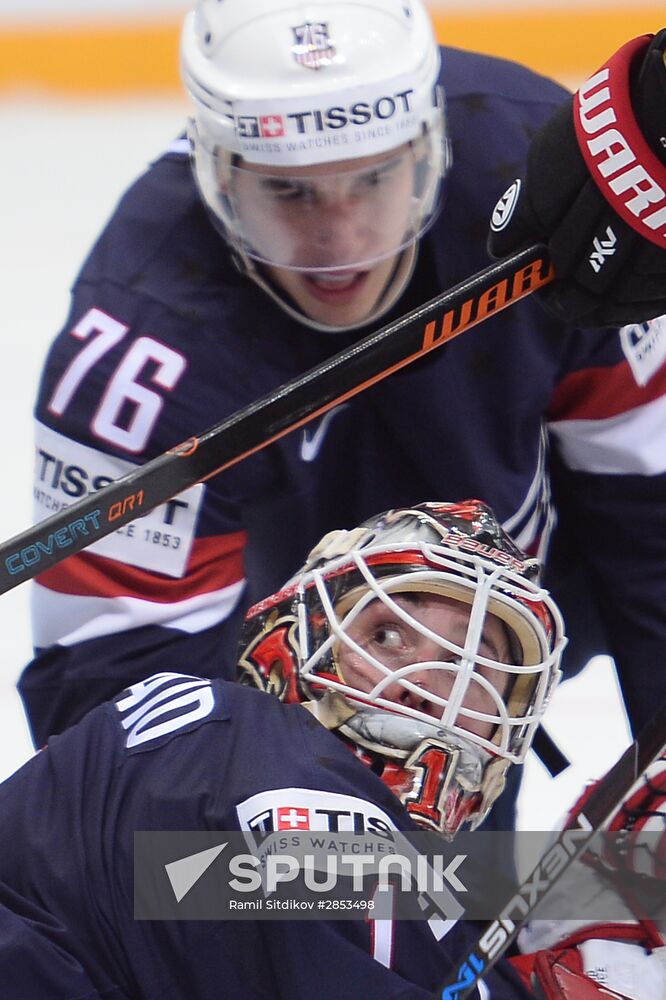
0, 674, 528, 1000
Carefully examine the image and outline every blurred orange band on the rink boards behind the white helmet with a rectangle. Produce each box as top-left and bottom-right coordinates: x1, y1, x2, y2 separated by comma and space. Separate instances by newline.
0, 0, 666, 95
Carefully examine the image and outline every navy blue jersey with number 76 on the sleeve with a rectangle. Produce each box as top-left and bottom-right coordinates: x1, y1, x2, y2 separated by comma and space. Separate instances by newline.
20, 49, 666, 742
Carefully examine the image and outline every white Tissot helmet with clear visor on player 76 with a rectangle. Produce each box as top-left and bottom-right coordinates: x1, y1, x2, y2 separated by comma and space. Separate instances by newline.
181, 0, 449, 286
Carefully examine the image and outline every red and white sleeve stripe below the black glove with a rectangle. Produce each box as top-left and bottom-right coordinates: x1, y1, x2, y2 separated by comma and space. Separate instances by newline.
548, 344, 666, 476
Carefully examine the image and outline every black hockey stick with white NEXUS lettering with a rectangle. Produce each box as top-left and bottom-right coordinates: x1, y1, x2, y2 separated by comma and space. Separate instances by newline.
434, 705, 666, 1000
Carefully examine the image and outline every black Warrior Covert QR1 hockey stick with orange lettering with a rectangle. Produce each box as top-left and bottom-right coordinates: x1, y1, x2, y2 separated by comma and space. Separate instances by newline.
0, 245, 553, 594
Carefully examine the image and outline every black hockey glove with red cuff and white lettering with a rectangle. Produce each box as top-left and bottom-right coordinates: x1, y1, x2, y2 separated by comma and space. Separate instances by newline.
488, 29, 666, 326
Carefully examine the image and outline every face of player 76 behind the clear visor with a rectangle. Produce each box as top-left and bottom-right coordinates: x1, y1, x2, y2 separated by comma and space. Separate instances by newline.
232, 145, 415, 326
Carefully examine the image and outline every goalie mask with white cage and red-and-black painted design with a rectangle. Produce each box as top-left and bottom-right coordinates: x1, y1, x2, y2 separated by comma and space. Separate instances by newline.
240, 500, 565, 836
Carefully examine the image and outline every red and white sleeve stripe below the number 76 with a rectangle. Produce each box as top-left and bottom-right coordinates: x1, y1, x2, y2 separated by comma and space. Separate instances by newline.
32, 532, 246, 648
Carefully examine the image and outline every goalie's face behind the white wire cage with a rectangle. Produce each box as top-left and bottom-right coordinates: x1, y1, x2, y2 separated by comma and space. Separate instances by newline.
339, 593, 509, 739
